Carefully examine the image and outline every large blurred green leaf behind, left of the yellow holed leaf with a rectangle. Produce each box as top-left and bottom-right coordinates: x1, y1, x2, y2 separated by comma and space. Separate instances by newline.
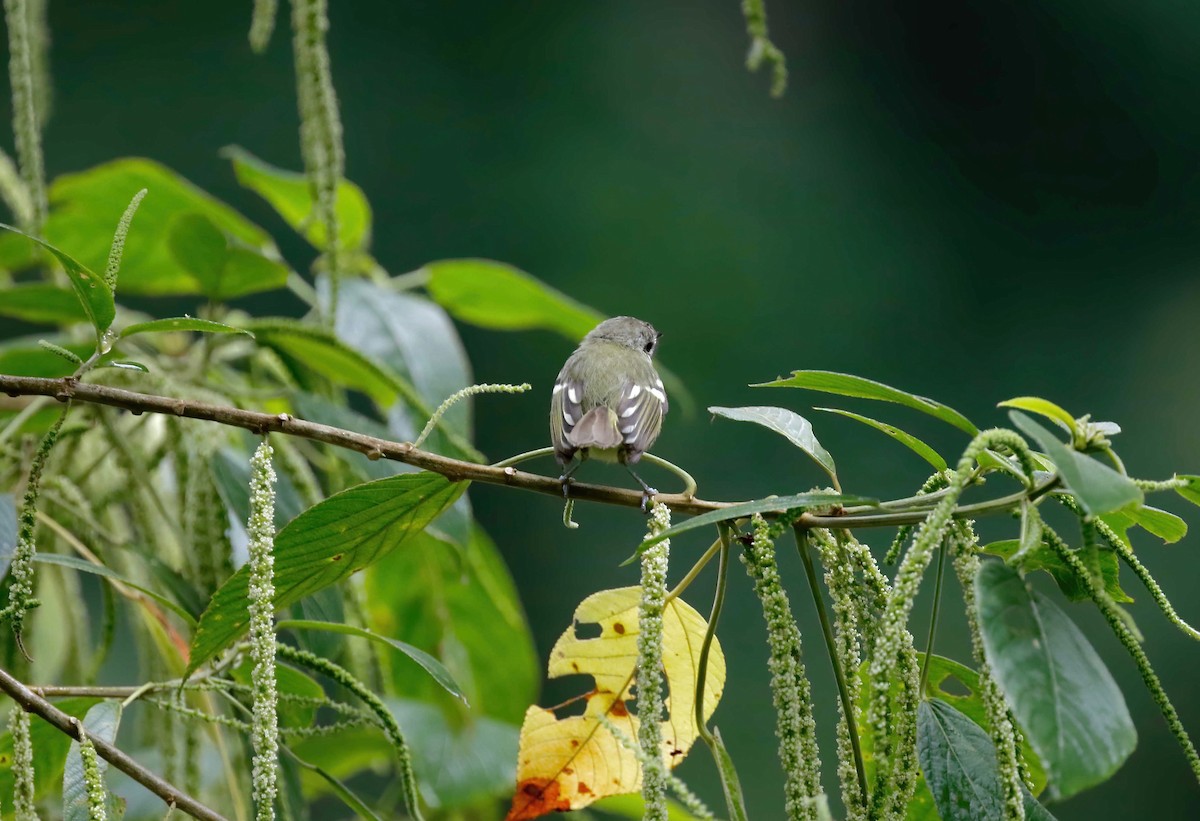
365, 527, 540, 724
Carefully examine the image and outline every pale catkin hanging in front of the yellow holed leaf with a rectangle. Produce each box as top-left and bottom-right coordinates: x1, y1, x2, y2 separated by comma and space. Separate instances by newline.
637, 502, 671, 821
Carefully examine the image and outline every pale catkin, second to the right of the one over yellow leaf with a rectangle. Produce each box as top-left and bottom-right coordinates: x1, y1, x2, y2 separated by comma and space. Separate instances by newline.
802, 529, 875, 821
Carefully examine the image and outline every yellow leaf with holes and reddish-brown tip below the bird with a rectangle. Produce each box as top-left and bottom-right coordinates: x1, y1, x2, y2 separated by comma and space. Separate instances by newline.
505, 587, 725, 821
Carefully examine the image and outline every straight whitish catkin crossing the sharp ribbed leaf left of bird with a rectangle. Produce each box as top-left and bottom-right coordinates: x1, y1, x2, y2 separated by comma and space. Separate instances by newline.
246, 439, 280, 821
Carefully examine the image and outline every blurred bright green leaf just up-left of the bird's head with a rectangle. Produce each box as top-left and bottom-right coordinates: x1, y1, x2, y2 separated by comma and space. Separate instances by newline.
422, 254, 604, 340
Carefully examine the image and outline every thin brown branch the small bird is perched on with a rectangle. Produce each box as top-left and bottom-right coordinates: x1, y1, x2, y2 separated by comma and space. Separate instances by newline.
0, 374, 1025, 528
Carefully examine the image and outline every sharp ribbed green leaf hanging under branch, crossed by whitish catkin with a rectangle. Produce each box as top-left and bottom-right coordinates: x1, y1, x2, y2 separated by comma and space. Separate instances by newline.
187, 473, 467, 675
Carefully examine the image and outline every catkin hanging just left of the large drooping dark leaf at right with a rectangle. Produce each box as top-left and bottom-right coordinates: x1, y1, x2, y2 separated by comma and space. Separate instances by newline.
943, 522, 1025, 821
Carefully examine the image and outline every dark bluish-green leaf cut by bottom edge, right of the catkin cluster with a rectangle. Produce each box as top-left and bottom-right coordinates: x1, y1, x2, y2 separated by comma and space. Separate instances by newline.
917, 699, 1054, 821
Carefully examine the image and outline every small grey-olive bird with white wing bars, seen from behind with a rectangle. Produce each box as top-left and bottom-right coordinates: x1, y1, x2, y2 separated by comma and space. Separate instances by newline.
550, 317, 667, 509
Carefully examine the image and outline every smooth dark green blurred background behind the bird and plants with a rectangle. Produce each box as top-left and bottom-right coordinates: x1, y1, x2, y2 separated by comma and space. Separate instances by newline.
9, 0, 1200, 820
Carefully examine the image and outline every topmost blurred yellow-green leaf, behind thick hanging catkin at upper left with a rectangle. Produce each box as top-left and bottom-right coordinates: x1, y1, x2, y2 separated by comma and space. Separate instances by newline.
221, 145, 371, 251
